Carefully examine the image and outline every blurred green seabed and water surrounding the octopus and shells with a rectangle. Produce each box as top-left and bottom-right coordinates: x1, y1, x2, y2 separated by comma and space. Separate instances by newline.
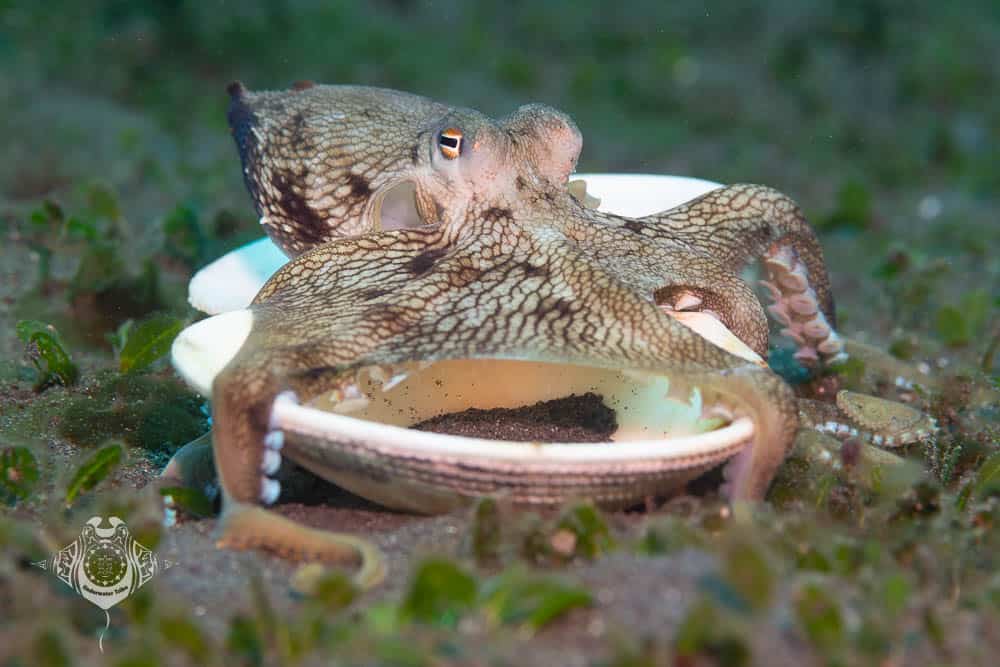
0, 0, 1000, 666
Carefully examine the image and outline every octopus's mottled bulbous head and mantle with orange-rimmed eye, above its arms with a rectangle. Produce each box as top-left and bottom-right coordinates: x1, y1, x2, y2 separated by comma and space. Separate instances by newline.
229, 84, 583, 257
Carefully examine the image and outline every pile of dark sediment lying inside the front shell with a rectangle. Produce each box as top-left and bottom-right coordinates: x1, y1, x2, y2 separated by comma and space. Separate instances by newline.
411, 392, 618, 442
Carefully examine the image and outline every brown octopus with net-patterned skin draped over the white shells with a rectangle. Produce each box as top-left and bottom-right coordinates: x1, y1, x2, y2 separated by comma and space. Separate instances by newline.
197, 84, 936, 584
